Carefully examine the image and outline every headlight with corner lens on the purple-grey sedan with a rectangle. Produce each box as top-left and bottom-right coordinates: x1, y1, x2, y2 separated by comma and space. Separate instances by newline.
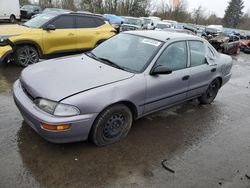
35, 99, 80, 117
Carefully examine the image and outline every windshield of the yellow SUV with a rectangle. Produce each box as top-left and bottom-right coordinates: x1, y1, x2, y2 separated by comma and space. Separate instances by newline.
23, 14, 56, 28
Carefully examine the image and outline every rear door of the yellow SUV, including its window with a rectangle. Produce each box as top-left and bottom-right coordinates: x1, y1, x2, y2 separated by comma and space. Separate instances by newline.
76, 16, 105, 49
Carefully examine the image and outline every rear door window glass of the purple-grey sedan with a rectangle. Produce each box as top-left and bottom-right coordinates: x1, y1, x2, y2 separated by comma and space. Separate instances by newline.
188, 41, 206, 67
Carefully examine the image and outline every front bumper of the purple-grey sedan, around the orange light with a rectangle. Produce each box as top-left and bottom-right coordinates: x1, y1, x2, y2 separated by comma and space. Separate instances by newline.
13, 80, 98, 143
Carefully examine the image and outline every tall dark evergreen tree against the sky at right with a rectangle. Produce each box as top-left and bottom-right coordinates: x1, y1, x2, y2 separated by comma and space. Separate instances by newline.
223, 0, 244, 28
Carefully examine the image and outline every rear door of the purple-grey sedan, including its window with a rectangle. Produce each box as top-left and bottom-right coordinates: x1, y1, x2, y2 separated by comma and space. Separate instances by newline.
188, 41, 217, 98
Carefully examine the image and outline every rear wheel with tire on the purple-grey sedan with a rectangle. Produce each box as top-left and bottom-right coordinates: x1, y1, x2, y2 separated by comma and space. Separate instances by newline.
198, 79, 220, 104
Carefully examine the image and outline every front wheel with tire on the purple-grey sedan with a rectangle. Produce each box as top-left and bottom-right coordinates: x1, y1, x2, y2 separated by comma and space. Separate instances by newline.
90, 104, 133, 146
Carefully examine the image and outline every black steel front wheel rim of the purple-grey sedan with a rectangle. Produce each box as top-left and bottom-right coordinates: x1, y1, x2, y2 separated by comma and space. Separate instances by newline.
103, 114, 125, 139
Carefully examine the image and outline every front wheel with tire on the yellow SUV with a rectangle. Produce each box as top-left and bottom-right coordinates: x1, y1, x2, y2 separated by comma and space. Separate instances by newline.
15, 46, 39, 67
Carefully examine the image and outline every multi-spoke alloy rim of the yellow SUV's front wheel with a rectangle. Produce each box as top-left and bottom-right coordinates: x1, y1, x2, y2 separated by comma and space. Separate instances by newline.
19, 49, 38, 66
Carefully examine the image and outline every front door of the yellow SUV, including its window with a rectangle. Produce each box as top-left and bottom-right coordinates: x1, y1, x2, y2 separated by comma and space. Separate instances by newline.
43, 15, 77, 54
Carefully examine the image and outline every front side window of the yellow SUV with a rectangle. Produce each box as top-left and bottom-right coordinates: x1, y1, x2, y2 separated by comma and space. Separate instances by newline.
51, 16, 75, 29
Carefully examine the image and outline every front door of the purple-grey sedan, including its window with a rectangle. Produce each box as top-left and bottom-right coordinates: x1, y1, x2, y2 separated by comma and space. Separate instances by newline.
144, 41, 190, 113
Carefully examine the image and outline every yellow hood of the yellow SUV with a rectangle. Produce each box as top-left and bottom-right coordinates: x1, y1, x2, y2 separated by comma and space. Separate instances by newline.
0, 25, 32, 36
